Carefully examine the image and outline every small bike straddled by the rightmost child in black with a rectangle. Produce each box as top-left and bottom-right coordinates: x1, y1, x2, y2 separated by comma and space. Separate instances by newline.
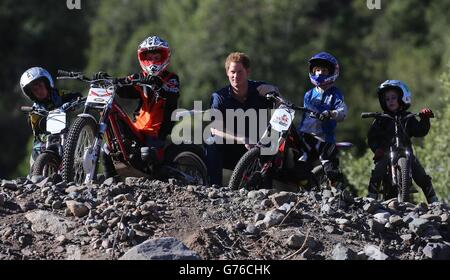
361, 112, 430, 202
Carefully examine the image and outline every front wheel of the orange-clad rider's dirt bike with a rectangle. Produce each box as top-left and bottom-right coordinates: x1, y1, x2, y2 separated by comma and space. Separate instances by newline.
62, 118, 96, 184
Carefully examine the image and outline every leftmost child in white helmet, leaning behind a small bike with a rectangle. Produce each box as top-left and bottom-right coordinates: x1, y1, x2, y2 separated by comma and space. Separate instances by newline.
20, 67, 82, 168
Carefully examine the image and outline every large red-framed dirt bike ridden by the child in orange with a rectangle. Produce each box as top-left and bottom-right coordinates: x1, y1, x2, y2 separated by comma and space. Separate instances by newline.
58, 71, 207, 185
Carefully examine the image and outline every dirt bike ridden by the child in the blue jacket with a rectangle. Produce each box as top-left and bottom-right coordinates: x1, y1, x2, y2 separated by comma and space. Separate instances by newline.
228, 93, 352, 189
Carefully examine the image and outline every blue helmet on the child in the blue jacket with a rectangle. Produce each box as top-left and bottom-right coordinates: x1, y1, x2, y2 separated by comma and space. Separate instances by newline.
309, 52, 339, 86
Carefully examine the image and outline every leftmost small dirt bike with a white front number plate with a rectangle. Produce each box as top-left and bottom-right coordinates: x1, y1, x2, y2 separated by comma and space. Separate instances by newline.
20, 98, 85, 177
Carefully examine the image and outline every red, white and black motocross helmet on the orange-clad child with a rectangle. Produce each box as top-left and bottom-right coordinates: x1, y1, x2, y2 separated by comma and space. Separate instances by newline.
138, 36, 170, 76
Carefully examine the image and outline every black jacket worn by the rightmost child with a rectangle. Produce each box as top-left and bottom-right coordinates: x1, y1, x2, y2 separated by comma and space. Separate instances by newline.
367, 111, 430, 152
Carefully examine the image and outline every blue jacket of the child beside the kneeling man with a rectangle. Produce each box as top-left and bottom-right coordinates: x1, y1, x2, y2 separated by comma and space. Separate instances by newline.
298, 86, 348, 143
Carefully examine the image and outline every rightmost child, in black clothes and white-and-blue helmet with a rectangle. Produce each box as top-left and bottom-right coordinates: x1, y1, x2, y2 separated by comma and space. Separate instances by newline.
367, 80, 438, 203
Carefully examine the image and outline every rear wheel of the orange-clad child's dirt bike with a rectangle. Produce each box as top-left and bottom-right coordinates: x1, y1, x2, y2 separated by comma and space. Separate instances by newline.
166, 145, 208, 186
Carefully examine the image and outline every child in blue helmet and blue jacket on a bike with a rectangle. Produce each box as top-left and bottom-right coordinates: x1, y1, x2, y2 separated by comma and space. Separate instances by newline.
297, 52, 348, 185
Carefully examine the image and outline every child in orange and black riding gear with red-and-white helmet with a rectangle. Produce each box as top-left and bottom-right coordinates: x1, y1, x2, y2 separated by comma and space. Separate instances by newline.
93, 36, 180, 178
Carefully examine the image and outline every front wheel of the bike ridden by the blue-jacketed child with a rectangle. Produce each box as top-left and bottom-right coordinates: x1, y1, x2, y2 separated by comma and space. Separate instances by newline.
228, 147, 267, 190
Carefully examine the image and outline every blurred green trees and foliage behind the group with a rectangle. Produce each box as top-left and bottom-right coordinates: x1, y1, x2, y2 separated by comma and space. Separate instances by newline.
0, 0, 450, 182
